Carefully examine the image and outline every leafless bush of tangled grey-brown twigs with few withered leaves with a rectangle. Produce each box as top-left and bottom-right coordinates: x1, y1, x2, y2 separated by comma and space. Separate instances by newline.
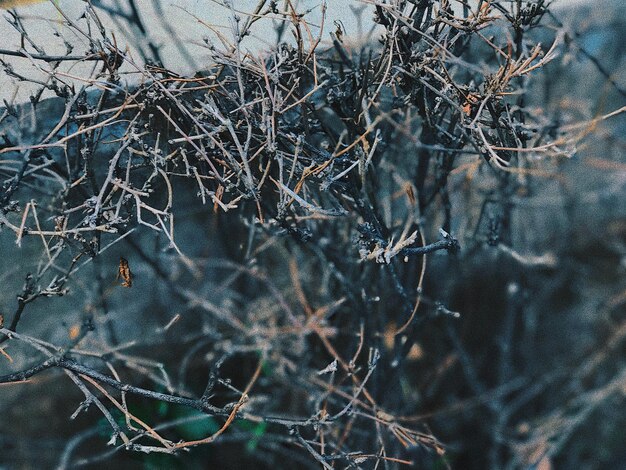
0, 0, 625, 468
